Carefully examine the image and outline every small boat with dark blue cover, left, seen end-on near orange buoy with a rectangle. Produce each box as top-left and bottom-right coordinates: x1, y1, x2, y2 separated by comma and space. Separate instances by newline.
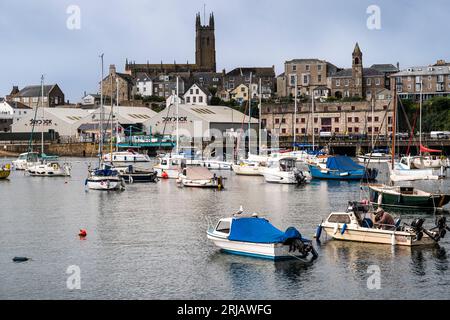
85, 165, 125, 191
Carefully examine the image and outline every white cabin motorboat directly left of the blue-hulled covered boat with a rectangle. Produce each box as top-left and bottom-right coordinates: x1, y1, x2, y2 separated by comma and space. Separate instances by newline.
262, 158, 306, 184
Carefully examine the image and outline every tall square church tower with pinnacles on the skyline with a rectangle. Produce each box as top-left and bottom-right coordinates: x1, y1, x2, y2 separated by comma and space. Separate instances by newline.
195, 13, 216, 72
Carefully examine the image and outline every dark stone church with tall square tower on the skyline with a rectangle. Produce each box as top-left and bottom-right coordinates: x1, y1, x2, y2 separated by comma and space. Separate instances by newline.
125, 13, 216, 77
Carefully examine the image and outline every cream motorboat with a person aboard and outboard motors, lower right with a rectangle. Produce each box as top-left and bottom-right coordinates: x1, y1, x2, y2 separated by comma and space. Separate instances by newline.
316, 204, 449, 247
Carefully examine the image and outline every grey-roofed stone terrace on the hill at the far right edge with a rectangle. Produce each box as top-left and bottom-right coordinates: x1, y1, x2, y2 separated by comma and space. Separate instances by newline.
391, 60, 450, 100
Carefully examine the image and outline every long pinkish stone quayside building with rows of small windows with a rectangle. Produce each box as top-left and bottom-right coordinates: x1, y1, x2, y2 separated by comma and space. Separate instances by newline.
261, 100, 393, 137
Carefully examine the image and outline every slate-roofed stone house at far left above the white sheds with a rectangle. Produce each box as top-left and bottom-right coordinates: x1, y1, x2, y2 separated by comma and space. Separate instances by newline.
7, 84, 65, 108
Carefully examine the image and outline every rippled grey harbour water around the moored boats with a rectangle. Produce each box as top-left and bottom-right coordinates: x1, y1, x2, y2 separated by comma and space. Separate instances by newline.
0, 159, 450, 299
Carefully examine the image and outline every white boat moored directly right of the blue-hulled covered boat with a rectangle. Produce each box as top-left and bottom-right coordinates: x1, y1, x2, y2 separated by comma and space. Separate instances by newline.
389, 157, 440, 182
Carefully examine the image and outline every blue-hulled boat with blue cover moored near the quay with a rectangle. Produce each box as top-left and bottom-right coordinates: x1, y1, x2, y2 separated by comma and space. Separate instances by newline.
308, 156, 378, 181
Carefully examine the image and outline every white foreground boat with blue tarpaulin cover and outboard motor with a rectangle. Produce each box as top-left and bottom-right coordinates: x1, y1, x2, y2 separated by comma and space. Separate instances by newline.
207, 210, 318, 262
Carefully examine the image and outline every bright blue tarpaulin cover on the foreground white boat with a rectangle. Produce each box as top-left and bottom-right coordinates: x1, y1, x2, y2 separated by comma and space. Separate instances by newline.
228, 217, 302, 243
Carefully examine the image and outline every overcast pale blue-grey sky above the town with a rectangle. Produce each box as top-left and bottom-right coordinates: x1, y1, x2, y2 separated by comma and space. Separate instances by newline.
0, 0, 450, 102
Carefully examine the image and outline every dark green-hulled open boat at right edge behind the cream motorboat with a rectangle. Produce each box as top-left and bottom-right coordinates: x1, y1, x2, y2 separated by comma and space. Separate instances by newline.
369, 185, 450, 211
